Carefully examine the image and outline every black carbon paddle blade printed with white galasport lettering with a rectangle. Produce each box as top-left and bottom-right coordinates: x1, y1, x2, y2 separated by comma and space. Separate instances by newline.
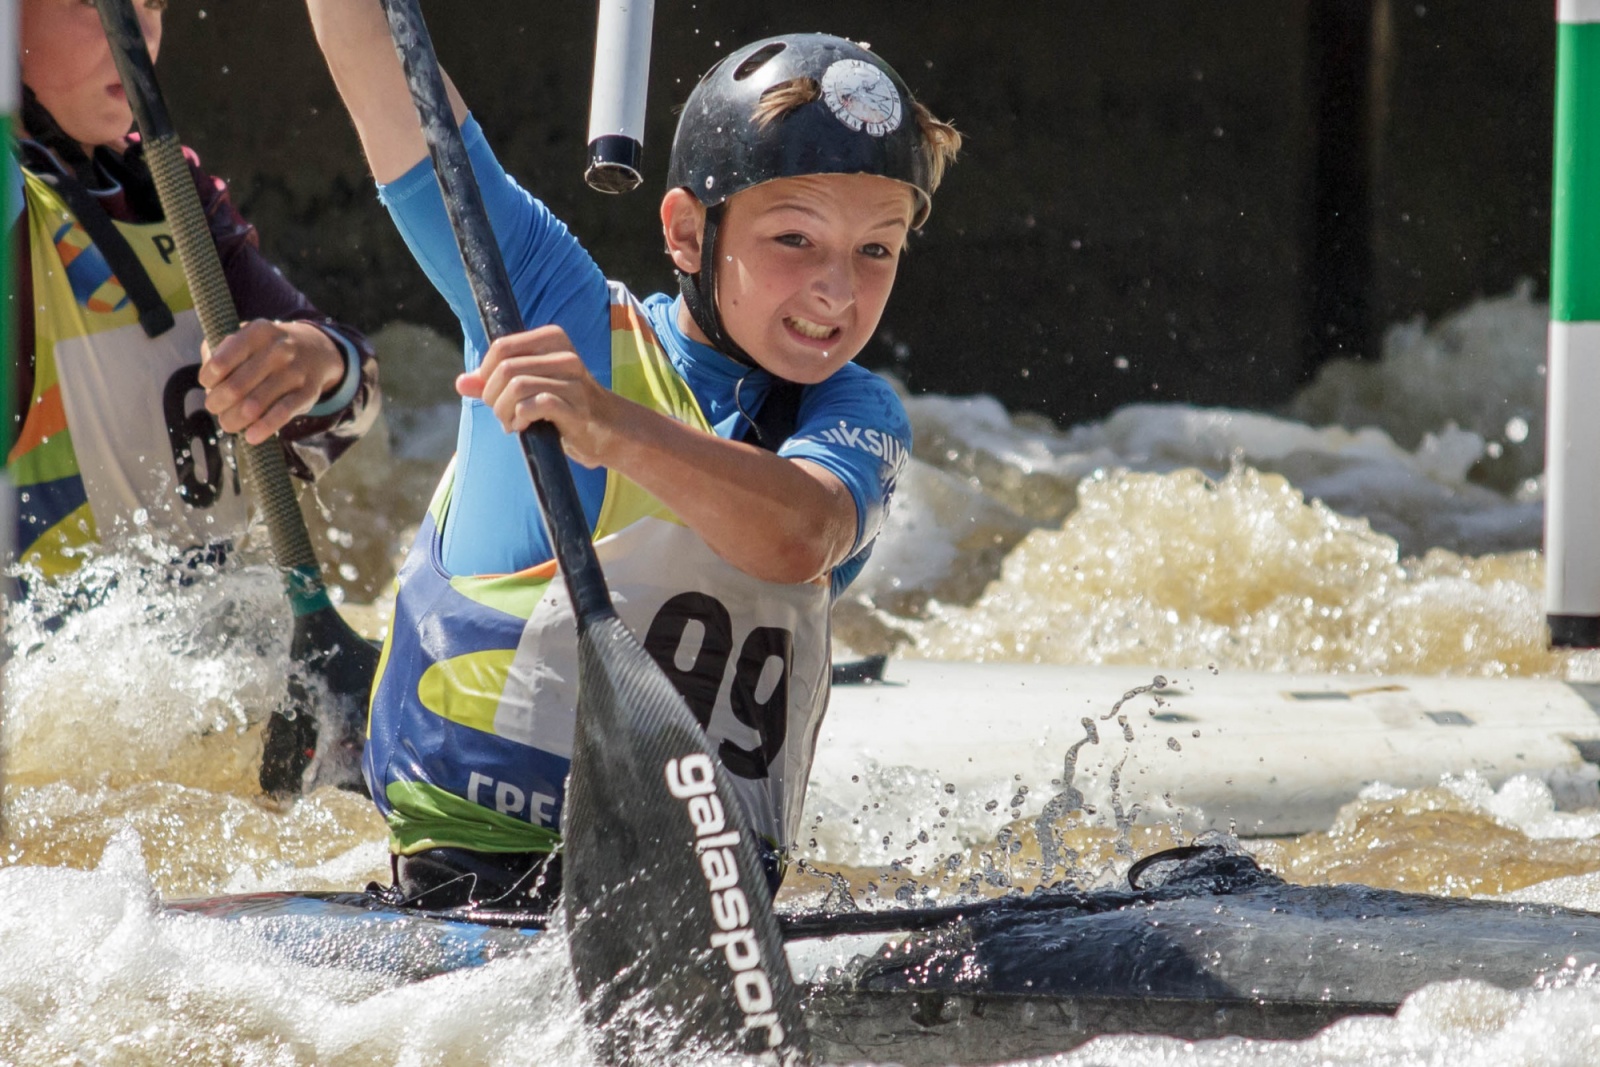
562, 616, 808, 1064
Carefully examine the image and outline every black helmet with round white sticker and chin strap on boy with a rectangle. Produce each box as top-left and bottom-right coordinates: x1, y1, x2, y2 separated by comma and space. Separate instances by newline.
667, 34, 933, 366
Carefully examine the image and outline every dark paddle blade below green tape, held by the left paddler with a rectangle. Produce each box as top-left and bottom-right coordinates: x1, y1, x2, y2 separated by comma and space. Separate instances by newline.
261, 606, 378, 800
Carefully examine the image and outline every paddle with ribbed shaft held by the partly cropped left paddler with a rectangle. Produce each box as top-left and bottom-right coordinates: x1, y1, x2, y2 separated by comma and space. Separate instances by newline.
94, 0, 378, 797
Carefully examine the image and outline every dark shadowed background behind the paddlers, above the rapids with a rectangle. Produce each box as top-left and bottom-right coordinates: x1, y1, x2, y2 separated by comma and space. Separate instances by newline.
160, 0, 1555, 422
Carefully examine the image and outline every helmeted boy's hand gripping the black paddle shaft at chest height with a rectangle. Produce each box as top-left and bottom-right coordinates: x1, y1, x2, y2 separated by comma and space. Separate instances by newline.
456, 326, 626, 467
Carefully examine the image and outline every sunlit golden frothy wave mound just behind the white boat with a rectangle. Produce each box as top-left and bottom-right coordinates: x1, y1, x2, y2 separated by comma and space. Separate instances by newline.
901, 467, 1562, 675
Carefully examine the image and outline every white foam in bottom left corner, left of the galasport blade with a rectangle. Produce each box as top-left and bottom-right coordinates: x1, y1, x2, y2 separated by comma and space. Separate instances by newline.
0, 832, 601, 1067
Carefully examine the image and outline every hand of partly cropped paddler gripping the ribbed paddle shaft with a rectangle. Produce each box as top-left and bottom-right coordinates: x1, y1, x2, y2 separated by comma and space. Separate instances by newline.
200, 318, 346, 445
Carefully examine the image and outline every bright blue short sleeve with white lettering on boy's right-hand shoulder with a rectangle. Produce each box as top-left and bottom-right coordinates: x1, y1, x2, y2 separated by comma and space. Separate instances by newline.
778, 363, 910, 595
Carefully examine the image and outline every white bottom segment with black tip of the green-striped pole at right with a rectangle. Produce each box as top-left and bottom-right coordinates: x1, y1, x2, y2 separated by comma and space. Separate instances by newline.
1544, 322, 1600, 627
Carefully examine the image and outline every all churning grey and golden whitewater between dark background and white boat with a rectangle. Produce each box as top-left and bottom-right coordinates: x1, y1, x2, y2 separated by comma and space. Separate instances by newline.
835, 290, 1561, 677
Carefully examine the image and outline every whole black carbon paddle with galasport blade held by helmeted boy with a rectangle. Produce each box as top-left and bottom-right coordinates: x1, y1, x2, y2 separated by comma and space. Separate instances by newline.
382, 0, 808, 1062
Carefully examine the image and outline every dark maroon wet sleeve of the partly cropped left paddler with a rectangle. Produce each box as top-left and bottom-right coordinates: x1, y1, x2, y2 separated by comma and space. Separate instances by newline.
184, 149, 381, 478
